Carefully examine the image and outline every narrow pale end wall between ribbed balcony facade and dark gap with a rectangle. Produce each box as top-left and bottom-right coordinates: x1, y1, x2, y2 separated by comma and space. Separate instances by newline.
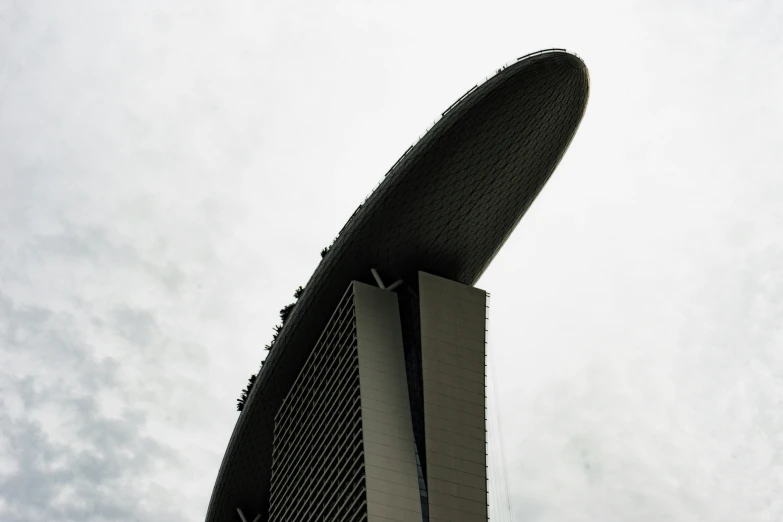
353, 282, 421, 522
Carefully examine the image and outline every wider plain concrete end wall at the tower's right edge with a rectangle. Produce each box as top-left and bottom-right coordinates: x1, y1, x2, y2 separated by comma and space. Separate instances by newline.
419, 272, 487, 522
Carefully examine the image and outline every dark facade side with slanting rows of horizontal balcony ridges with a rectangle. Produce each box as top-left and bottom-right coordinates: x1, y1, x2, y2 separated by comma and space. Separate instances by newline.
269, 285, 362, 522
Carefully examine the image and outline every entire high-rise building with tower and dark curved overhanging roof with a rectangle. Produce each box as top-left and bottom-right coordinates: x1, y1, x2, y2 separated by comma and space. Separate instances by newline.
206, 49, 589, 522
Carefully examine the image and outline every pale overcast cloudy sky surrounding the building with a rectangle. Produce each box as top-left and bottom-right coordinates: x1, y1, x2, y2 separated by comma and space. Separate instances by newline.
0, 0, 783, 522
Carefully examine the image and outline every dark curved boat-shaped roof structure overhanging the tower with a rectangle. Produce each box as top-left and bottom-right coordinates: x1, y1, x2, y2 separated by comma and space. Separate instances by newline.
207, 49, 589, 522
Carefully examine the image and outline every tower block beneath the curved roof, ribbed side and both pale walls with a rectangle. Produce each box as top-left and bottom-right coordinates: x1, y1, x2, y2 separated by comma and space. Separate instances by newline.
269, 272, 487, 522
